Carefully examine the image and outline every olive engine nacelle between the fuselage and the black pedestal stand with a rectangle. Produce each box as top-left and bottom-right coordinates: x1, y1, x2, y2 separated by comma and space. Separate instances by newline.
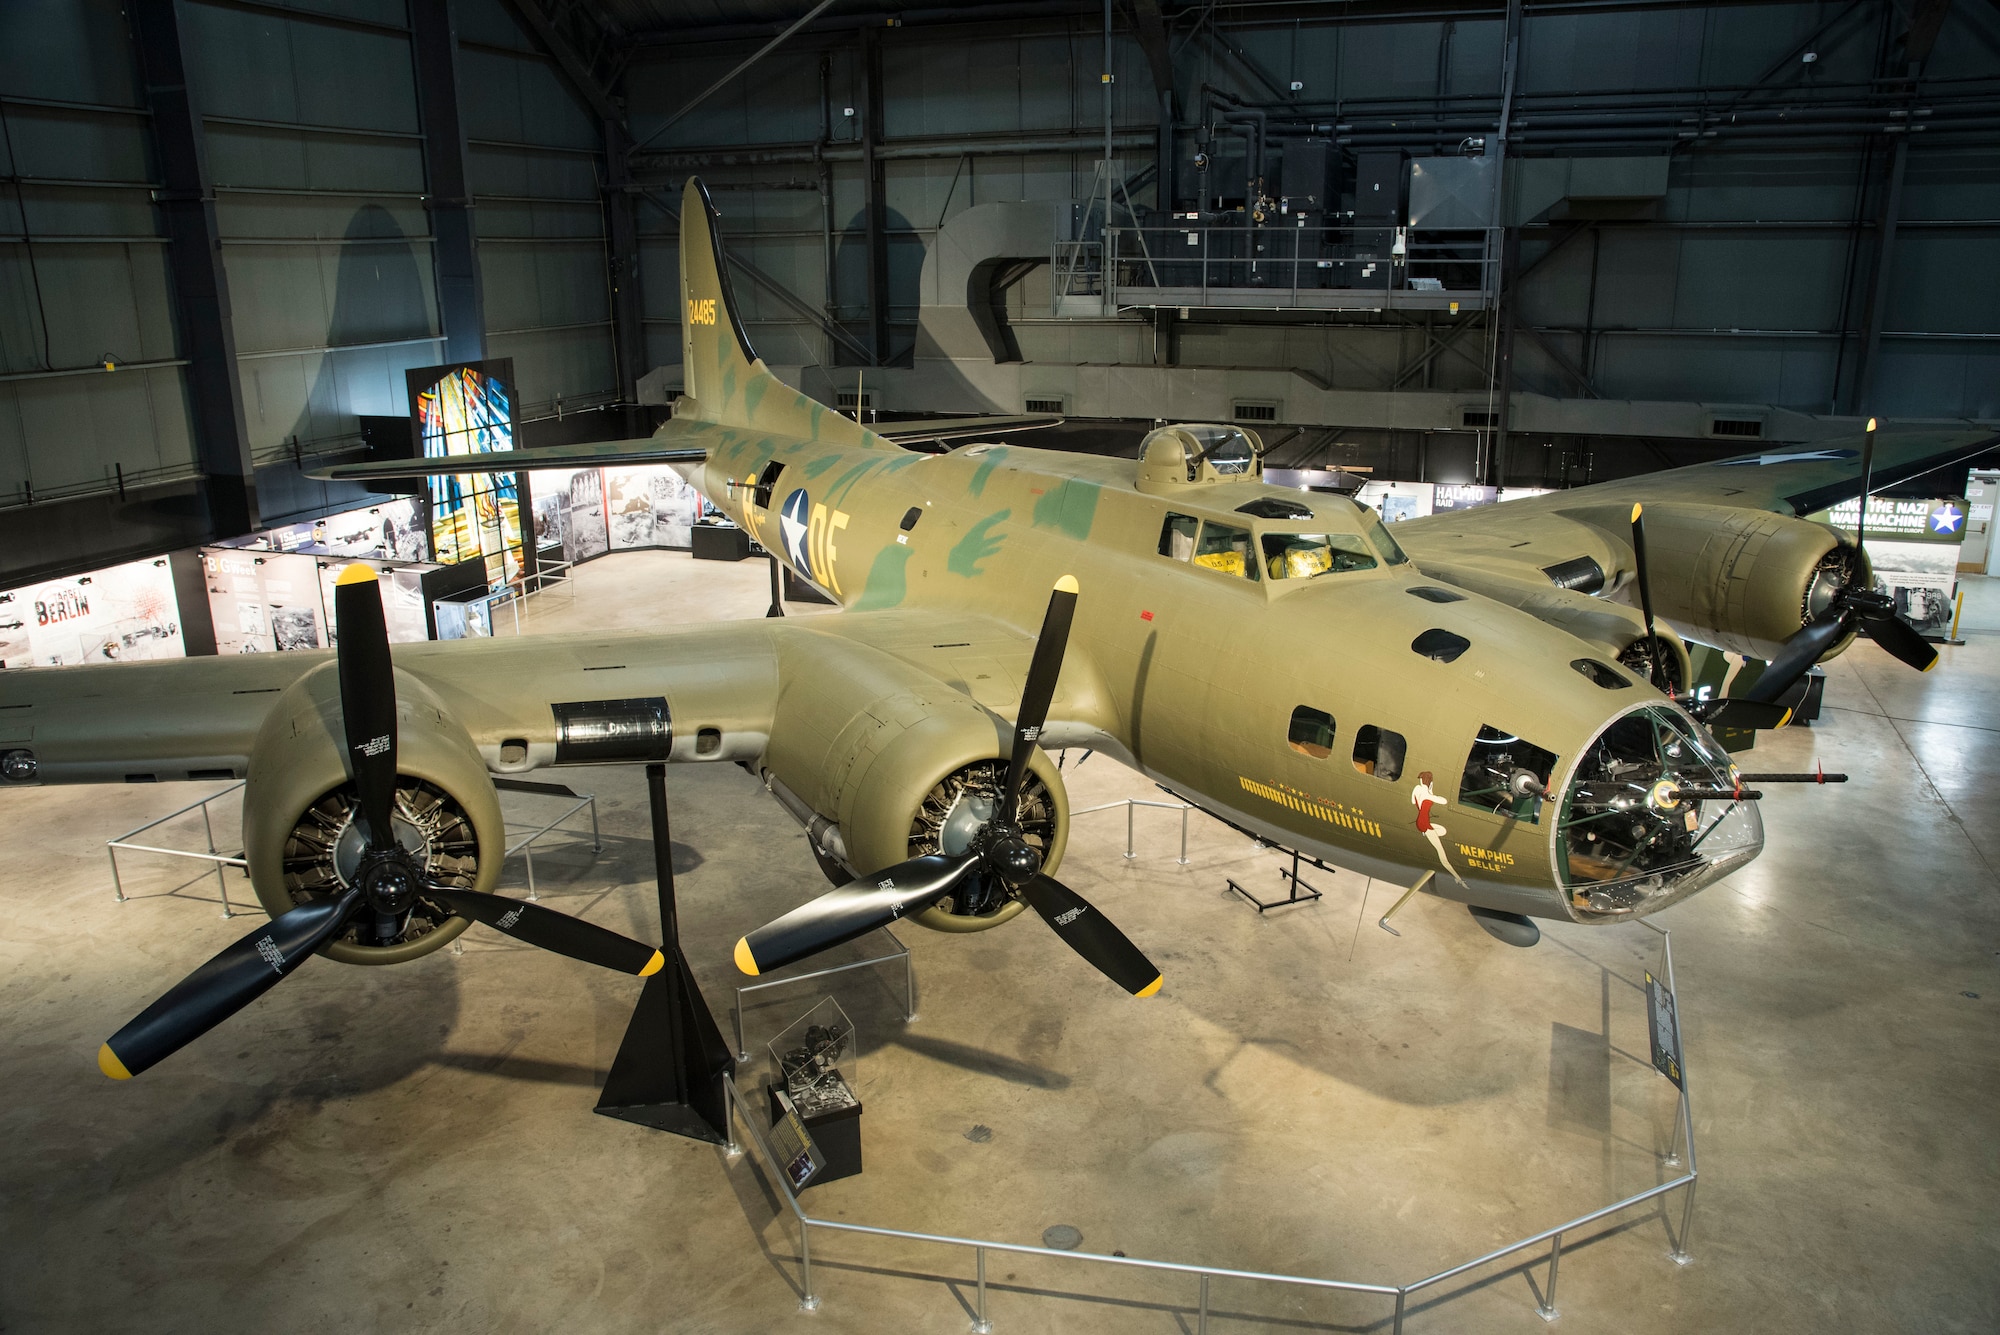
764, 636, 1070, 931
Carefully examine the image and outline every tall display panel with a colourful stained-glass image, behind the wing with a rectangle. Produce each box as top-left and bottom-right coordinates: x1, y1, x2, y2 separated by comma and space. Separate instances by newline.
406, 358, 522, 590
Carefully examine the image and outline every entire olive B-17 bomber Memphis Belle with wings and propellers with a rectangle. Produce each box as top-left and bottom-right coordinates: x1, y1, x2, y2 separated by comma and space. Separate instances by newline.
0, 180, 1992, 1075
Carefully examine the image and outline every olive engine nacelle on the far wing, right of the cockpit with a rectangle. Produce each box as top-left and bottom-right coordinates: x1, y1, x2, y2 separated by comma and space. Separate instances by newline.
1564, 502, 1870, 660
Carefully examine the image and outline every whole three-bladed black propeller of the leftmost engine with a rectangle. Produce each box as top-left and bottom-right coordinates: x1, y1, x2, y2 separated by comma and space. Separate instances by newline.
98, 562, 666, 1079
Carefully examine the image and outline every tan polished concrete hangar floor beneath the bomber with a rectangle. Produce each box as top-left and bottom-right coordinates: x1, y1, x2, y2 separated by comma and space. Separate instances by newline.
0, 554, 2000, 1335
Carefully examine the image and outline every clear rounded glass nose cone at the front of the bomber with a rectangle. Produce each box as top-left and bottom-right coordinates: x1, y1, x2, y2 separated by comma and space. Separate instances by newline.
1556, 705, 1764, 919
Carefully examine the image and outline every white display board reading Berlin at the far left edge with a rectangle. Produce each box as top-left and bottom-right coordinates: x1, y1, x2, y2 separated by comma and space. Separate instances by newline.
0, 556, 188, 668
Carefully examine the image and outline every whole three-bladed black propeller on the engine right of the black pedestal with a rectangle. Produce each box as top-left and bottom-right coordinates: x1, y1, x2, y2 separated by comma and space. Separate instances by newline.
736, 576, 1160, 997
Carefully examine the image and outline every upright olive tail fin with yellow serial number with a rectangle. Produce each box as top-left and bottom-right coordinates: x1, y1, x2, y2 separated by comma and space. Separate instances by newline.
674, 176, 896, 450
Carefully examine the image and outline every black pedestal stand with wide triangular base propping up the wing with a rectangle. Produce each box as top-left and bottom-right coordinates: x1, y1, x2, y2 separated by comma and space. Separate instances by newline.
596, 765, 736, 1145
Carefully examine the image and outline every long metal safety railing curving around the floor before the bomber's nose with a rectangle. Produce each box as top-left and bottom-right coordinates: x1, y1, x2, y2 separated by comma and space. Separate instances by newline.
724, 923, 1696, 1335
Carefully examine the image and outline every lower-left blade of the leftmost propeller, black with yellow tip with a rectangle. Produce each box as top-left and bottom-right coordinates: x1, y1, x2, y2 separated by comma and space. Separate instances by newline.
98, 887, 362, 1079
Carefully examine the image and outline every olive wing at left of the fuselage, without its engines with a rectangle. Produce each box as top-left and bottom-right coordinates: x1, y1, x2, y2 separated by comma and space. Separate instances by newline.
0, 610, 1096, 783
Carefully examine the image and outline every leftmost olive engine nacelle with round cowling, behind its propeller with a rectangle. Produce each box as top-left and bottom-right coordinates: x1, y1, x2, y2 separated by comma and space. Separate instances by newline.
244, 662, 506, 963
